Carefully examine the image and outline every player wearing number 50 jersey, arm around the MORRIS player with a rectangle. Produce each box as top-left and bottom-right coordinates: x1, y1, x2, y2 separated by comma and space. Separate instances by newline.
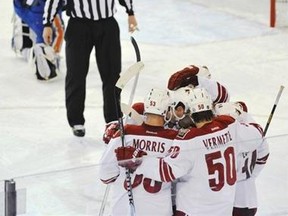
116, 88, 262, 216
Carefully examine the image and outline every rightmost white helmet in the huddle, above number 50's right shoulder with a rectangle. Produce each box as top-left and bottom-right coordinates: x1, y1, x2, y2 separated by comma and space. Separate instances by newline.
214, 102, 244, 119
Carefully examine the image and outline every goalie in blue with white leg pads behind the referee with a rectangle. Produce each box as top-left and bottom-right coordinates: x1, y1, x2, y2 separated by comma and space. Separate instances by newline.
12, 0, 64, 80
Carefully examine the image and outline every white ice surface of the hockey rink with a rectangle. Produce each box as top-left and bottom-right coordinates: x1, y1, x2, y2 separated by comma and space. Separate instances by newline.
0, 0, 288, 216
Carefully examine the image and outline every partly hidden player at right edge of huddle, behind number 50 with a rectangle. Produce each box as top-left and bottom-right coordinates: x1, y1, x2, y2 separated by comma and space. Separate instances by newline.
214, 102, 269, 216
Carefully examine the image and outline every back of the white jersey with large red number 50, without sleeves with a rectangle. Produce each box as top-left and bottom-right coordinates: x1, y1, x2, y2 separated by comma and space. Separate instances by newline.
171, 116, 236, 216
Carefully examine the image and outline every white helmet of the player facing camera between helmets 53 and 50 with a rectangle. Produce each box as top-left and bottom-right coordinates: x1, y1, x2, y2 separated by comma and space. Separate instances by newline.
170, 86, 193, 119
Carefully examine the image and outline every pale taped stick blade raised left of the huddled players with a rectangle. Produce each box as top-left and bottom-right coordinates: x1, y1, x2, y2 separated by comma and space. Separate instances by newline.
116, 61, 144, 89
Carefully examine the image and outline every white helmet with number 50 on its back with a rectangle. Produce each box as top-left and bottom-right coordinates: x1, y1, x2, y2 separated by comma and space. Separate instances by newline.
190, 88, 213, 113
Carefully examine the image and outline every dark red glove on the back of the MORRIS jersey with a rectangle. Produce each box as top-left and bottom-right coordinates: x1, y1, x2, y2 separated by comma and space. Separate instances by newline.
115, 146, 147, 172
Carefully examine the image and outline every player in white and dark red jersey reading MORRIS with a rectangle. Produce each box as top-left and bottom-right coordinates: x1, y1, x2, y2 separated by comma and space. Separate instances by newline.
100, 89, 177, 216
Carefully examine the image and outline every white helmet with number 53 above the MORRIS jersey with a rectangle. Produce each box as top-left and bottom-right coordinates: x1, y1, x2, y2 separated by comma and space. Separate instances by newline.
144, 88, 170, 116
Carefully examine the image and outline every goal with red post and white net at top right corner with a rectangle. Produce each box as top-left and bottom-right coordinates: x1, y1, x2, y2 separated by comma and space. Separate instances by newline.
270, 0, 288, 27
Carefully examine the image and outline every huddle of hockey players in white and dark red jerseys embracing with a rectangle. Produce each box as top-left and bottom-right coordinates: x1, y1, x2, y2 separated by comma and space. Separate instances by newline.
100, 65, 269, 216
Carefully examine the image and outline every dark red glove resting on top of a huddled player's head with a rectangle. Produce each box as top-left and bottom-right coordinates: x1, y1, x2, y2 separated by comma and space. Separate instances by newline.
168, 65, 199, 90
